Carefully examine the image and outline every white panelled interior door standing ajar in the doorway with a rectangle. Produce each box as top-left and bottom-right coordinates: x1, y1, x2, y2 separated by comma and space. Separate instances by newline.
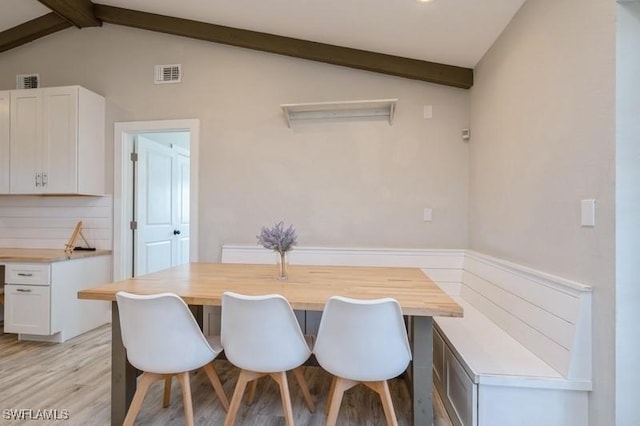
134, 135, 189, 276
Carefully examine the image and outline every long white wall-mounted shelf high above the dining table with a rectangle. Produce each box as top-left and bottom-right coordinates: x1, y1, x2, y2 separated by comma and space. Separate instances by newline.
280, 99, 398, 127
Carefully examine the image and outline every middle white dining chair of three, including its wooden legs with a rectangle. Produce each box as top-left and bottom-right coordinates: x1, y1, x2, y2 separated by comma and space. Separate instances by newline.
220, 292, 315, 426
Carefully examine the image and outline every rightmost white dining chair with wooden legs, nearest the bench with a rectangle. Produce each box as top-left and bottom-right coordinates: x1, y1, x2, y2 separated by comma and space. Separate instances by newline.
313, 296, 411, 426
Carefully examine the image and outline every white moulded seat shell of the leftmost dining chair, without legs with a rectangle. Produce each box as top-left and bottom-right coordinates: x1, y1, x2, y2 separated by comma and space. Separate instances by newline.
116, 291, 218, 374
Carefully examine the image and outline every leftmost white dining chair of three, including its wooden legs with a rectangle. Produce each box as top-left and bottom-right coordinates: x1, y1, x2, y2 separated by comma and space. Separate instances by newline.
116, 291, 229, 425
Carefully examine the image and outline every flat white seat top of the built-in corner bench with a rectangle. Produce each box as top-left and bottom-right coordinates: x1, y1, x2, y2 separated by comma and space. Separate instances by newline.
434, 296, 591, 390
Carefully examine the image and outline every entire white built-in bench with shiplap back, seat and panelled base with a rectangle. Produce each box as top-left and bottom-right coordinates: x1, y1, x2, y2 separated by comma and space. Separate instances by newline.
425, 251, 592, 426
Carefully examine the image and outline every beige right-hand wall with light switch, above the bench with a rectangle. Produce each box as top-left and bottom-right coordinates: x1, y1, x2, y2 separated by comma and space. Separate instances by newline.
469, 0, 616, 426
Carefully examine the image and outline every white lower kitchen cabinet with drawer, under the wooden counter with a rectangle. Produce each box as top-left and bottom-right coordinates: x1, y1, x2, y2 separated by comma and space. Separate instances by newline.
4, 256, 111, 343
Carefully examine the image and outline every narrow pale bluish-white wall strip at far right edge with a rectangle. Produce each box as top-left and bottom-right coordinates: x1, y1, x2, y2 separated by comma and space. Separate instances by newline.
616, 2, 640, 426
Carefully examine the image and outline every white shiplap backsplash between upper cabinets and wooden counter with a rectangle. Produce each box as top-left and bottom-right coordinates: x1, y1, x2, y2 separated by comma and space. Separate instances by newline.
0, 195, 113, 249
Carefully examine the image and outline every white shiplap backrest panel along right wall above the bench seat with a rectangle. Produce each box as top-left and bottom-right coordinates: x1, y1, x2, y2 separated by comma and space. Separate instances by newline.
460, 251, 592, 383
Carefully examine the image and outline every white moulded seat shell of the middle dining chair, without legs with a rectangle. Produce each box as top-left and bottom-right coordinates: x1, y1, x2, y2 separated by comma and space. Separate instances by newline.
220, 292, 311, 373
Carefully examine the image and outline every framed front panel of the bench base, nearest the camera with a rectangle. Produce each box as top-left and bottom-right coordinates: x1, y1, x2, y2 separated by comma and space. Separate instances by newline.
445, 348, 478, 426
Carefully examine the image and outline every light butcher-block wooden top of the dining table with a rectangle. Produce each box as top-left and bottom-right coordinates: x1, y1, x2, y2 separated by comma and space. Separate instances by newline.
78, 263, 462, 317
